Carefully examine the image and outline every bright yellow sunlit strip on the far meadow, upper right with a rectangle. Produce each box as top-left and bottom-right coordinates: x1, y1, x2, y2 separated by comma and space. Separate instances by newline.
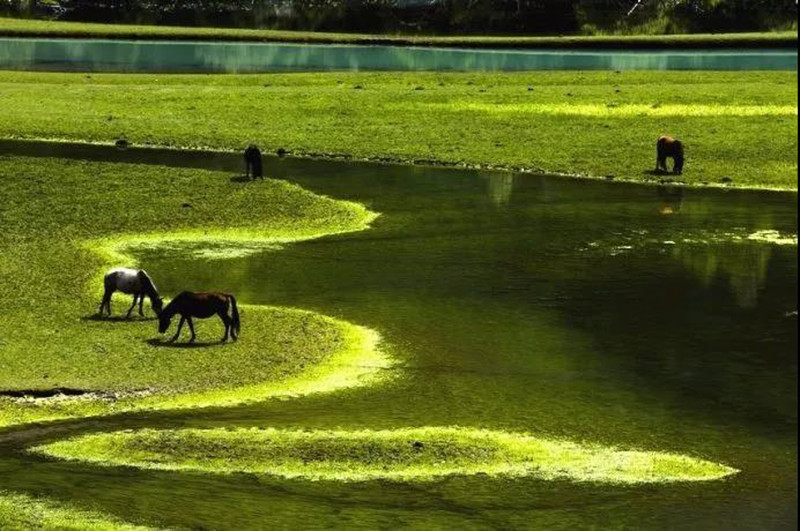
416, 101, 797, 117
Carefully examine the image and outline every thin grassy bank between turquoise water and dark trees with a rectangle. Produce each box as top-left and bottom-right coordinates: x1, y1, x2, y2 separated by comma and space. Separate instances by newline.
0, 18, 797, 48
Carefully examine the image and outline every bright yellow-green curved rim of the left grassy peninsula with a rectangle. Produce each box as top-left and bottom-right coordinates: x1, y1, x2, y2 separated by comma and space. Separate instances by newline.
0, 194, 393, 429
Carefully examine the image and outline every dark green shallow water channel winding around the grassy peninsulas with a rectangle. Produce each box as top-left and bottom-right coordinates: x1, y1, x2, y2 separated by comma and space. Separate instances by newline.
0, 144, 797, 529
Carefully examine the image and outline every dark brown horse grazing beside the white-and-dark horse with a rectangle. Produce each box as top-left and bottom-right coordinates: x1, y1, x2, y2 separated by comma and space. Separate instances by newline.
158, 291, 240, 343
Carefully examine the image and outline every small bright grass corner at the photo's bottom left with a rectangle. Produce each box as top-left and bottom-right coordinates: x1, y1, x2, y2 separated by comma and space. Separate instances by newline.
0, 490, 154, 531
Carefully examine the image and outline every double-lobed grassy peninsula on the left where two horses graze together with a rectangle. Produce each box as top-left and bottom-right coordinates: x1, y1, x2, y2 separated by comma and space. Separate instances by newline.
0, 157, 387, 426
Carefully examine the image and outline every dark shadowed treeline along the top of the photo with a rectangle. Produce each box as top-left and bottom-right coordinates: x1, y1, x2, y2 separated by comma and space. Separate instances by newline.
0, 0, 797, 34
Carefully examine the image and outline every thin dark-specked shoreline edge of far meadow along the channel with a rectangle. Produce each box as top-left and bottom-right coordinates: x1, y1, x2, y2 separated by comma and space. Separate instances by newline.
0, 135, 798, 194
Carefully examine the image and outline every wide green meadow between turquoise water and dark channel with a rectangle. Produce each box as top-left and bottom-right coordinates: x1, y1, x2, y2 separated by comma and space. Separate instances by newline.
0, 72, 798, 189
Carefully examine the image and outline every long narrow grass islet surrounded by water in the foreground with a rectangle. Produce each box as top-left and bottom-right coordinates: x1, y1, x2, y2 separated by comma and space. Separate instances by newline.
33, 427, 737, 483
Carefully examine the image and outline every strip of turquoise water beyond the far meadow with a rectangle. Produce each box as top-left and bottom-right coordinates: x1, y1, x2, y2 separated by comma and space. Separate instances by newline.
0, 38, 797, 72
